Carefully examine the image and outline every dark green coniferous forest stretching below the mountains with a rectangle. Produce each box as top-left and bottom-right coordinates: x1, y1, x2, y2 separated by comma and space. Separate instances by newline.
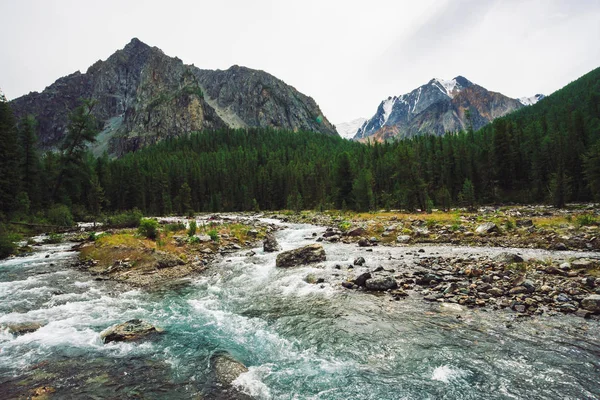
0, 69, 600, 222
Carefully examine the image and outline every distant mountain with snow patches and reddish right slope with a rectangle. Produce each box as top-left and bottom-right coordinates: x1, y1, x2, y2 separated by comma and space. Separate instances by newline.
354, 76, 528, 141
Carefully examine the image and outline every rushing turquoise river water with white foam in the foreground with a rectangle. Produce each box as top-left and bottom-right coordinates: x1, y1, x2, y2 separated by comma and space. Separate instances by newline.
0, 225, 600, 399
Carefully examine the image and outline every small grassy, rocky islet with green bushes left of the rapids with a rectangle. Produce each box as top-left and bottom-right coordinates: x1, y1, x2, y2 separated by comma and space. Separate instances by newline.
74, 215, 279, 287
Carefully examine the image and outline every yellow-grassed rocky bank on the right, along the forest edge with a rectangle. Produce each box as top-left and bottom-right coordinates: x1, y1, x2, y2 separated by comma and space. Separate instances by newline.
269, 205, 600, 251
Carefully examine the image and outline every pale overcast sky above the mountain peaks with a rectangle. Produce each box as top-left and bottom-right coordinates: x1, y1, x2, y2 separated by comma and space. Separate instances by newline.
0, 0, 600, 123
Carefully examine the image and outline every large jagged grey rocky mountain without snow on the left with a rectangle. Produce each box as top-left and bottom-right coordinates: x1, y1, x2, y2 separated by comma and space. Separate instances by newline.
11, 38, 337, 155
